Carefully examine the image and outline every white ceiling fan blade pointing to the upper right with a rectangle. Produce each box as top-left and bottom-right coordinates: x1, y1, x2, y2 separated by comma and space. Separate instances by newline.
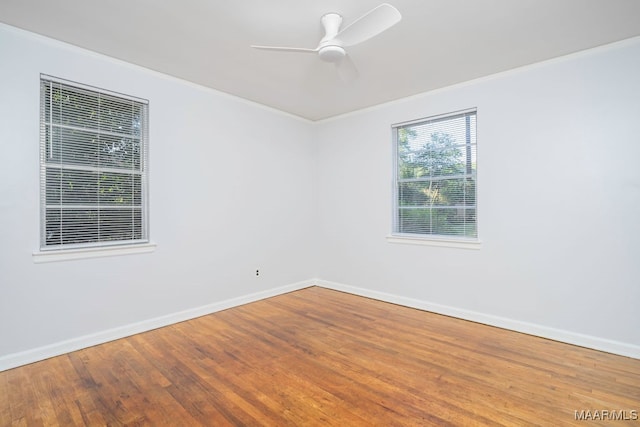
336, 3, 402, 46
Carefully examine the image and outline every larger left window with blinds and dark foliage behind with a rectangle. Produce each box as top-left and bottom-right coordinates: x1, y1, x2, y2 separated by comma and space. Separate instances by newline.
40, 76, 148, 249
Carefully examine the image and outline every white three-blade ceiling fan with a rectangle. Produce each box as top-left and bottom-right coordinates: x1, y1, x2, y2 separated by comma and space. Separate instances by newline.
251, 3, 402, 82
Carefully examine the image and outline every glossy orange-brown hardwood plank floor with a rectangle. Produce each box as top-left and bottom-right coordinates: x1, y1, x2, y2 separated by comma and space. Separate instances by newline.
0, 287, 640, 427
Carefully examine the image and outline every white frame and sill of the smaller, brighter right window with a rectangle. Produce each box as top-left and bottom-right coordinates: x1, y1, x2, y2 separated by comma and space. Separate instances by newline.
387, 107, 482, 249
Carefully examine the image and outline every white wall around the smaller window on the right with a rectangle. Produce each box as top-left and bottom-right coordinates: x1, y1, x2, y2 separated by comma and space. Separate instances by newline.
316, 39, 640, 357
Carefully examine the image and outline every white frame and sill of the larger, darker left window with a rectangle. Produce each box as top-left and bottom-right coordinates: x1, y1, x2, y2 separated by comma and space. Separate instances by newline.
33, 74, 155, 262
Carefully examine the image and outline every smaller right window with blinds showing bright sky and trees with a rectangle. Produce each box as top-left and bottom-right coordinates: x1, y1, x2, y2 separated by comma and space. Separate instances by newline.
393, 110, 478, 239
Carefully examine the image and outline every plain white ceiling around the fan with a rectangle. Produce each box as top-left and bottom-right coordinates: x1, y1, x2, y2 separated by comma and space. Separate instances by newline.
0, 0, 640, 120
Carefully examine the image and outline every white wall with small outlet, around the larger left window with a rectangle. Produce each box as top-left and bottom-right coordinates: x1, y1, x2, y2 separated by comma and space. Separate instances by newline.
0, 26, 314, 369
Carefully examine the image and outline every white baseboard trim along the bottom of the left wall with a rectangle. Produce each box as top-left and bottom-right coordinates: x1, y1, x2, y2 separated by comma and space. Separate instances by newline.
0, 280, 315, 372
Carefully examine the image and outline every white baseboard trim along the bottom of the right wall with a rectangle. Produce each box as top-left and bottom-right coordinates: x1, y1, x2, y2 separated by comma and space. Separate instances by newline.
315, 279, 640, 359
